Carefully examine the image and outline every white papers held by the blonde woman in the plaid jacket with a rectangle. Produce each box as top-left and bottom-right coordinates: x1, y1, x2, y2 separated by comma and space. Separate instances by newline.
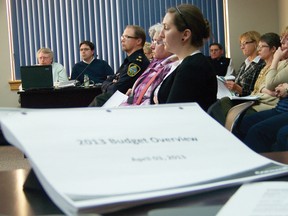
217, 76, 259, 100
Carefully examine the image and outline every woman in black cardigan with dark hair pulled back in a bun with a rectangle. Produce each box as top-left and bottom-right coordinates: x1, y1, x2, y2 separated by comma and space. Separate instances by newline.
151, 4, 217, 111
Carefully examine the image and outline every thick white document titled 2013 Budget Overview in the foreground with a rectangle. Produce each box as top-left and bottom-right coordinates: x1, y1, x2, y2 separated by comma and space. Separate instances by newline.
2, 103, 288, 214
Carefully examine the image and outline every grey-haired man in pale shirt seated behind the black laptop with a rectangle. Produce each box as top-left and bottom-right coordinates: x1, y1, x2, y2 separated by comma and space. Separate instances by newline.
37, 48, 68, 83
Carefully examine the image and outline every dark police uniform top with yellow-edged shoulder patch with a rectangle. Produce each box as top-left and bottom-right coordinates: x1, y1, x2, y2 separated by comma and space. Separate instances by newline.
102, 49, 150, 94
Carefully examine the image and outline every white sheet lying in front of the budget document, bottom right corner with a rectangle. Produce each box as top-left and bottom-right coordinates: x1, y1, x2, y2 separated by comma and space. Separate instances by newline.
217, 181, 288, 216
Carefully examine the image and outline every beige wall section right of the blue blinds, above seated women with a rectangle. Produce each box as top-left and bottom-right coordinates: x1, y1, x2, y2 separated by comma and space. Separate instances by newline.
228, 0, 280, 71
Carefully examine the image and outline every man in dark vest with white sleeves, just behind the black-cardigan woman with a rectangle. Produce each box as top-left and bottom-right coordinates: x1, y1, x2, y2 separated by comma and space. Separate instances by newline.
208, 43, 234, 76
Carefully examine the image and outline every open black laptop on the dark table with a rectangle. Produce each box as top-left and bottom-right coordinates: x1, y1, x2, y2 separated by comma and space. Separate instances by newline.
20, 65, 53, 90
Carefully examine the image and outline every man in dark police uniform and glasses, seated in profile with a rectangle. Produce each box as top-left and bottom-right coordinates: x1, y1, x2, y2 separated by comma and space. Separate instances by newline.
90, 25, 150, 106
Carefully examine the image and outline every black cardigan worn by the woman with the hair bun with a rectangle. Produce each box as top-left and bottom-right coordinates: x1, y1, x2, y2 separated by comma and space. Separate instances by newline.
153, 53, 217, 111
